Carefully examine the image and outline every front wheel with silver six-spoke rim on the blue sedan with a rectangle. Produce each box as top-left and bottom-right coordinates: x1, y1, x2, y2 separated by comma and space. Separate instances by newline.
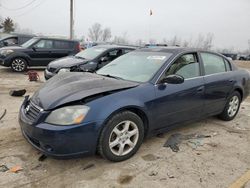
98, 111, 144, 162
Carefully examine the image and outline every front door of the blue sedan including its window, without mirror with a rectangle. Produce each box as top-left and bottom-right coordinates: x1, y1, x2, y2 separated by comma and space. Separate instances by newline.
155, 53, 204, 129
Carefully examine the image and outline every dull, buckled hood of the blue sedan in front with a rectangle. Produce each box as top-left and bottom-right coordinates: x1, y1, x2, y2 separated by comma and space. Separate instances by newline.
31, 72, 139, 110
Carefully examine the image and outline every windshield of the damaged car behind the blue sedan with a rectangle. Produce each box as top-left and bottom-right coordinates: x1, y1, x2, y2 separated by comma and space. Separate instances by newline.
75, 47, 107, 59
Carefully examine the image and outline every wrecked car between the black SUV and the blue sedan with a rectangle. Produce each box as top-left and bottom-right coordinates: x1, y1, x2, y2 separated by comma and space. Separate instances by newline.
44, 45, 135, 80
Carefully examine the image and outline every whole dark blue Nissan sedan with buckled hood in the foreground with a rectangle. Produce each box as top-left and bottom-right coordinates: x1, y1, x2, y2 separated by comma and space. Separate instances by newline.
19, 48, 250, 161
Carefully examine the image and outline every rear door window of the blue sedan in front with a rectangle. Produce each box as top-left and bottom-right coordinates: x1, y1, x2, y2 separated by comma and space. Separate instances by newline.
201, 53, 226, 75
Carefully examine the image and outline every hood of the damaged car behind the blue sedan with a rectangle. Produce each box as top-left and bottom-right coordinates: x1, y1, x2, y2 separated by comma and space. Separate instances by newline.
48, 56, 88, 69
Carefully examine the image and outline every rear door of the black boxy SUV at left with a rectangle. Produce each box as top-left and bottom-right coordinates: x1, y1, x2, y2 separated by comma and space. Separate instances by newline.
51, 40, 74, 59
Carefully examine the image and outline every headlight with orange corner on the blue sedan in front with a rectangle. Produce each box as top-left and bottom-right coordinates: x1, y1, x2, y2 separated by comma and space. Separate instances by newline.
45, 105, 89, 125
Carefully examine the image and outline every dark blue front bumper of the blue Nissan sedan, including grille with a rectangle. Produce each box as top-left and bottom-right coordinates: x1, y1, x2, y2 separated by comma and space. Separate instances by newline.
19, 98, 103, 159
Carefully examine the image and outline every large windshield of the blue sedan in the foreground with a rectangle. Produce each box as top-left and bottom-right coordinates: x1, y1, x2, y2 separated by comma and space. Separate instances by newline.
96, 52, 172, 82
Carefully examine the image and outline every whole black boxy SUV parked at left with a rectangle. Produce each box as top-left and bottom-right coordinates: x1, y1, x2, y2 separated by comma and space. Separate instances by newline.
0, 37, 80, 72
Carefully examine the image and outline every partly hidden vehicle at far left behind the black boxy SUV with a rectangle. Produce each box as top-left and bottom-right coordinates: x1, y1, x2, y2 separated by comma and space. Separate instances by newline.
0, 34, 35, 48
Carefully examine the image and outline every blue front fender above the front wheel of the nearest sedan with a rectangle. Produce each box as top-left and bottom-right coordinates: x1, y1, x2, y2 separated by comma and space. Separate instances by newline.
85, 84, 155, 132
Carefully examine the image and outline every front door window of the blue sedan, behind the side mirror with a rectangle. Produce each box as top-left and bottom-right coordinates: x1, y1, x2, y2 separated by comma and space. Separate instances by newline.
165, 54, 200, 79
